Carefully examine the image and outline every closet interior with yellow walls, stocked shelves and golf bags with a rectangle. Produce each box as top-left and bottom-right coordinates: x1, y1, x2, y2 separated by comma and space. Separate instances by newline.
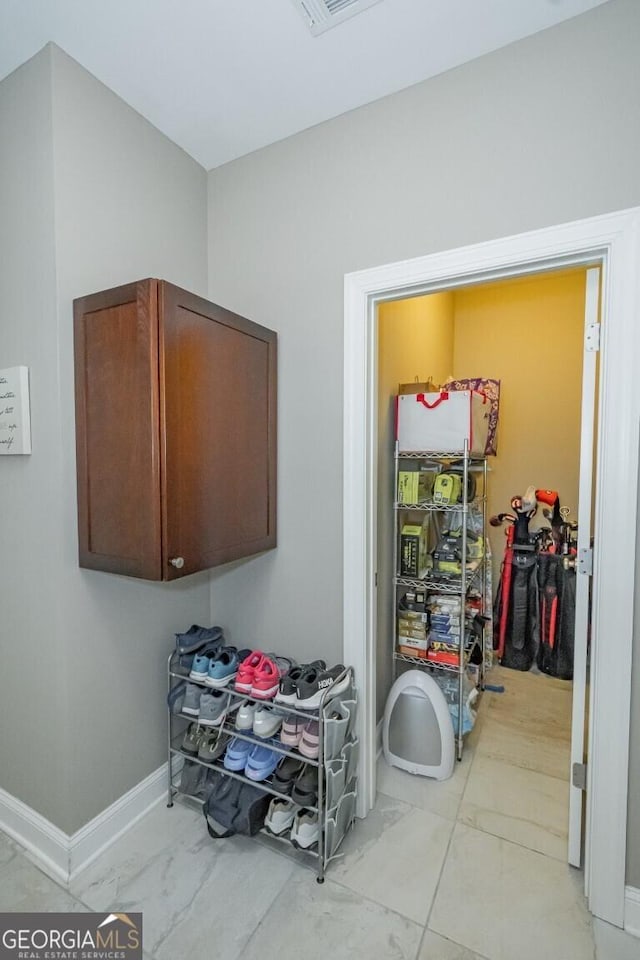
376, 267, 596, 812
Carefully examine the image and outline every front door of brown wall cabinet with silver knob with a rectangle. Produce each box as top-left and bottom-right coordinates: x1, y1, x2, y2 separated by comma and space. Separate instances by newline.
159, 282, 276, 579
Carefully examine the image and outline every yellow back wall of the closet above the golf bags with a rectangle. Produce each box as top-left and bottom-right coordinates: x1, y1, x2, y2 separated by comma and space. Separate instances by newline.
453, 268, 585, 588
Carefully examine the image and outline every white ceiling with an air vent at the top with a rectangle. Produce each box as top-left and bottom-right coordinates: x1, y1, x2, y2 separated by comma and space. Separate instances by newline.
0, 0, 607, 169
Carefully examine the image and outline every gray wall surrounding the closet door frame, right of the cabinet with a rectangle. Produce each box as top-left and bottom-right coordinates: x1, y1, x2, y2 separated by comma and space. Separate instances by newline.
209, 0, 640, 886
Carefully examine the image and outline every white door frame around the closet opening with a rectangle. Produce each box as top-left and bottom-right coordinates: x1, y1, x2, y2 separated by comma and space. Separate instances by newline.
343, 208, 640, 927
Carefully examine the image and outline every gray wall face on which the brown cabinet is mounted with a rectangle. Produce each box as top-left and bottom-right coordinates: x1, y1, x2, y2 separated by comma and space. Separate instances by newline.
52, 47, 210, 832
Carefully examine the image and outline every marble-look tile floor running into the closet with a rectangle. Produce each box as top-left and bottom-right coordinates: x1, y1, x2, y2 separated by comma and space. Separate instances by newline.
0, 670, 640, 960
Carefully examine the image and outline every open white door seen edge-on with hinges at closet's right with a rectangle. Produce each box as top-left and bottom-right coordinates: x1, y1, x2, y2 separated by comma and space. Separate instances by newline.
568, 267, 600, 867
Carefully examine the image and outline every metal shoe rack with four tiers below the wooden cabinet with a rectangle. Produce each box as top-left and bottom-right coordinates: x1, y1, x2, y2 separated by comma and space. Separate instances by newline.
167, 651, 359, 883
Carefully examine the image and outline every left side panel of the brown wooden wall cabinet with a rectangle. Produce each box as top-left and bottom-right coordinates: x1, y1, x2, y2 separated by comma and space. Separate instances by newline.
74, 280, 162, 580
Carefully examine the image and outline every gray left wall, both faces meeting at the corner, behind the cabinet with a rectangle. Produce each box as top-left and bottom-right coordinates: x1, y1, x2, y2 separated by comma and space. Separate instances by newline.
0, 47, 210, 833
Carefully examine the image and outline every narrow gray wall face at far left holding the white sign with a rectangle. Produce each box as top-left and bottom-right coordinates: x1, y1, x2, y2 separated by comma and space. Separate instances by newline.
0, 50, 66, 818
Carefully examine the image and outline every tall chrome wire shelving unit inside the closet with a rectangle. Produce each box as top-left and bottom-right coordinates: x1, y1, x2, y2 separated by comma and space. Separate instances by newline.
393, 441, 491, 760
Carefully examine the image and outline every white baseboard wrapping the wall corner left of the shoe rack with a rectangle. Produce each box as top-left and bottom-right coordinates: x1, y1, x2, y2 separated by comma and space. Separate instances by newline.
0, 758, 174, 886
